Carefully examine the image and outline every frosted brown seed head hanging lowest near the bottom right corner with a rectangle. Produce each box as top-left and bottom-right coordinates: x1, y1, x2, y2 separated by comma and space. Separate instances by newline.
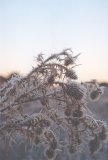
89, 136, 100, 154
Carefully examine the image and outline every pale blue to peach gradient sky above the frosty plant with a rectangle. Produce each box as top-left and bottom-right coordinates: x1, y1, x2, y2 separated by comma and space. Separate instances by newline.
0, 0, 108, 81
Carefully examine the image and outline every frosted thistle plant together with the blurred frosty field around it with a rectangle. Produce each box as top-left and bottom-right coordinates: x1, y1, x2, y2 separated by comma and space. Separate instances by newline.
0, 49, 108, 160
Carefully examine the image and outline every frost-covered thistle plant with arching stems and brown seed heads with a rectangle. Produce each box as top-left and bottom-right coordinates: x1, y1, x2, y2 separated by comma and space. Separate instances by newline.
0, 49, 107, 159
